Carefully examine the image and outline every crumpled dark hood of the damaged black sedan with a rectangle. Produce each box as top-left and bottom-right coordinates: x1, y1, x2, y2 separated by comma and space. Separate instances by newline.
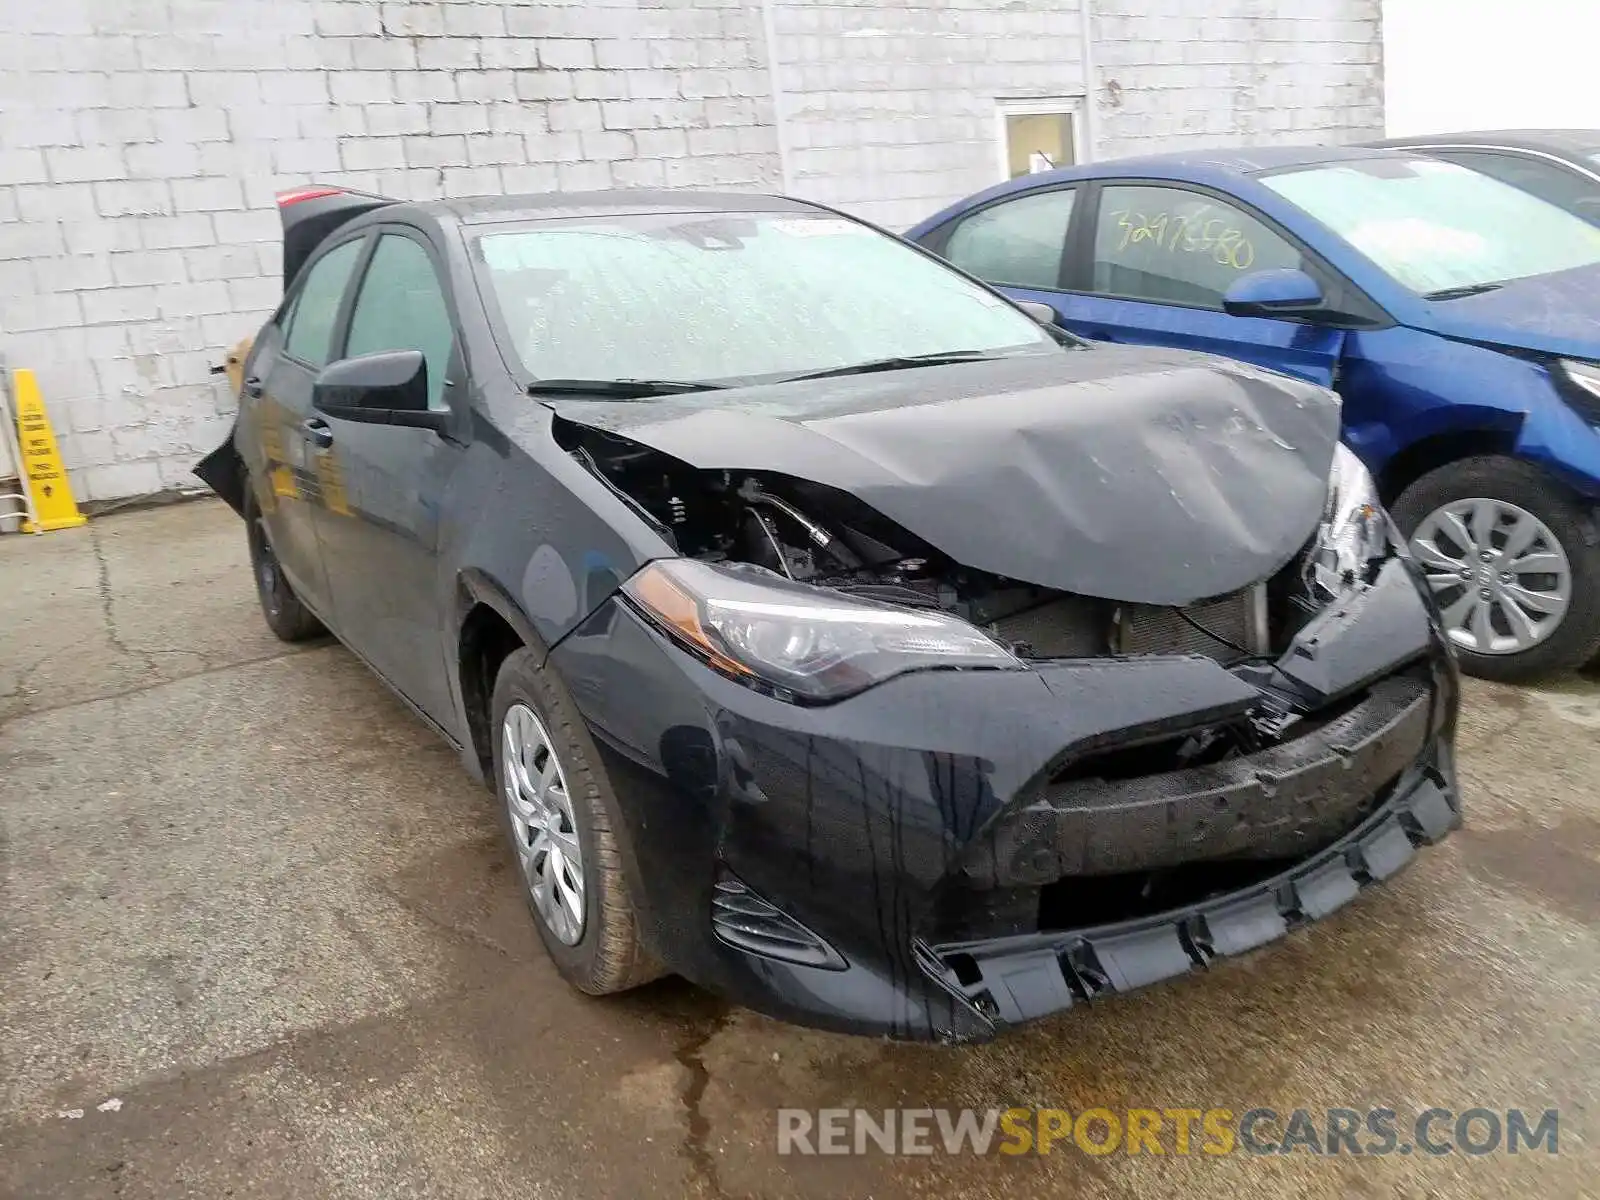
552, 349, 1339, 605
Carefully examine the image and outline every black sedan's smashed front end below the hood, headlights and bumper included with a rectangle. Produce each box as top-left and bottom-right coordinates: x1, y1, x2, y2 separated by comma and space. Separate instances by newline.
552, 366, 1459, 1040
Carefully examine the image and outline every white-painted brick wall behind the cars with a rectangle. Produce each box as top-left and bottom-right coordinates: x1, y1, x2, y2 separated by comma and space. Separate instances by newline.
0, 0, 1381, 501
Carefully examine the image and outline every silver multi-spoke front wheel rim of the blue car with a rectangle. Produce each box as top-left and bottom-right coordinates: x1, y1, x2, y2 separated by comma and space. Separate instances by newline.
1411, 496, 1573, 654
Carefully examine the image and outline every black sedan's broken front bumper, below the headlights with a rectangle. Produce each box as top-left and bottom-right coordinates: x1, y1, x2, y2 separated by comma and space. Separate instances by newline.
550, 560, 1459, 1042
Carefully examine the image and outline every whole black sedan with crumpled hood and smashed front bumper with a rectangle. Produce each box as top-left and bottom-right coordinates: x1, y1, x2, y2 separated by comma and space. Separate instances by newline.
197, 189, 1459, 1040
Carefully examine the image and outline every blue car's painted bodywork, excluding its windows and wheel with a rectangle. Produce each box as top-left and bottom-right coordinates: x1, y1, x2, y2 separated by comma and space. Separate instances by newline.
907, 149, 1600, 499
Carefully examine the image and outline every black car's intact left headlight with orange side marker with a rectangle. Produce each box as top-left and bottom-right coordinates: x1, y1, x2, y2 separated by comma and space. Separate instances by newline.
622, 558, 1021, 701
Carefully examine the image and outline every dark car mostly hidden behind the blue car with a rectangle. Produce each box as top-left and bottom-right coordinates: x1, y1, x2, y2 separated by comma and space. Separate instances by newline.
1373, 130, 1600, 226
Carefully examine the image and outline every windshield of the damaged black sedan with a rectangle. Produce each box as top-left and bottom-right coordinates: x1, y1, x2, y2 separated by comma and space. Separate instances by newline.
475, 213, 1059, 381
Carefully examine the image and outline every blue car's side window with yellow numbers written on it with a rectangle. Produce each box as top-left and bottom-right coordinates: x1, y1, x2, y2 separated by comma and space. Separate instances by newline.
1091, 184, 1304, 309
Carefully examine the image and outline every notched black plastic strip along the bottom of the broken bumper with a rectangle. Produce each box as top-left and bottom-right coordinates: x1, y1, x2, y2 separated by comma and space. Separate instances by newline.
920, 768, 1461, 1027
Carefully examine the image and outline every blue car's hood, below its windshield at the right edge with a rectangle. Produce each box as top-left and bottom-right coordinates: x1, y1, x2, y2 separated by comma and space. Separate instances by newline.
1427, 264, 1600, 360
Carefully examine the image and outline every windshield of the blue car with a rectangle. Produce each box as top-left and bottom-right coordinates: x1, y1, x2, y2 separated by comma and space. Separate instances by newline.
1261, 158, 1600, 294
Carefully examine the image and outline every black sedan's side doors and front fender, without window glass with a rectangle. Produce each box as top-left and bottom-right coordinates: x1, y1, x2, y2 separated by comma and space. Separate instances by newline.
227, 202, 672, 746
